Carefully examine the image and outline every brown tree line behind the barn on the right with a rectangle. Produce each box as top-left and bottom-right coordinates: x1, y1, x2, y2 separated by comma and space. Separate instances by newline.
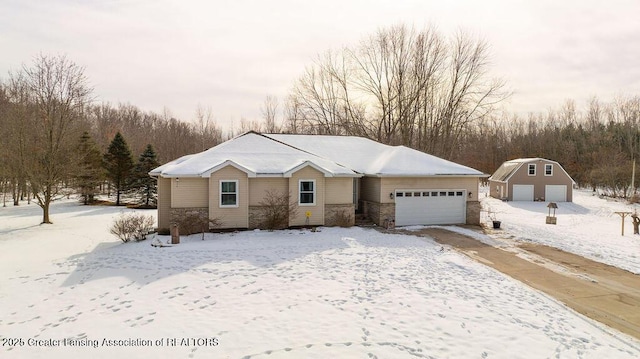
451, 96, 640, 197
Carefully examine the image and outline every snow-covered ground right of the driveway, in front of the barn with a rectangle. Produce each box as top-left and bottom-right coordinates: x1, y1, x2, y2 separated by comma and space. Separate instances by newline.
481, 190, 640, 274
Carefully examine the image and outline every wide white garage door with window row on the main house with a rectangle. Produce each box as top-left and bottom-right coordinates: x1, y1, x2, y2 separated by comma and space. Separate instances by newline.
395, 189, 467, 226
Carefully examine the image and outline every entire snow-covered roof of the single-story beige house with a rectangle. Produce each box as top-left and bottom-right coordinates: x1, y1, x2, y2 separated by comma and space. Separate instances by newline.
149, 132, 485, 177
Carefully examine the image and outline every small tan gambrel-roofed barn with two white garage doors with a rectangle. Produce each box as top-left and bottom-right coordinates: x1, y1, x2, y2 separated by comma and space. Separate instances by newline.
489, 158, 575, 202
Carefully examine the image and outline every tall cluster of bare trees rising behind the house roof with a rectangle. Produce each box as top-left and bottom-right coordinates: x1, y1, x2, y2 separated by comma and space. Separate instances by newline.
287, 22, 508, 158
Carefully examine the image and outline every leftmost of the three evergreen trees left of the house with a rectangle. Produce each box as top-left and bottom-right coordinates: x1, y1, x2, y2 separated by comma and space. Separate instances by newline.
76, 131, 105, 204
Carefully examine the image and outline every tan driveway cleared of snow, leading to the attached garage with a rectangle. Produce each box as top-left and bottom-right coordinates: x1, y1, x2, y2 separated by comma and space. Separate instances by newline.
411, 228, 640, 339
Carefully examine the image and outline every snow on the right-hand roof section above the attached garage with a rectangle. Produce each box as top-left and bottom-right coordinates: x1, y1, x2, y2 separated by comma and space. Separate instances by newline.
265, 134, 484, 176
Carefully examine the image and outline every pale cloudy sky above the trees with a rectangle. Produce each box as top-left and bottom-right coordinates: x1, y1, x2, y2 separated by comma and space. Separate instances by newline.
0, 0, 640, 126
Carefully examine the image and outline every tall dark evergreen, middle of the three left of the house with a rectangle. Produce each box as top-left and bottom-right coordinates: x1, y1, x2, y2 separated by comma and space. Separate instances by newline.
104, 132, 134, 206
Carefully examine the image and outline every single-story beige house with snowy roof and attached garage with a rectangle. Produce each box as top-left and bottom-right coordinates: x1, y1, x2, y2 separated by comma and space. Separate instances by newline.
149, 132, 487, 228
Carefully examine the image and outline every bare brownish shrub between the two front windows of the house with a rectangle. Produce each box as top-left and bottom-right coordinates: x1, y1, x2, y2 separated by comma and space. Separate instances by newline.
260, 190, 298, 230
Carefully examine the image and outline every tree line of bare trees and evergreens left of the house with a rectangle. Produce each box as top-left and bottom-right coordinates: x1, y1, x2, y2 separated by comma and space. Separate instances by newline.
0, 55, 223, 223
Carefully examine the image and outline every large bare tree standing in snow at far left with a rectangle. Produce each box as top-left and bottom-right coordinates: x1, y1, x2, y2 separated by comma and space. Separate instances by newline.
10, 55, 92, 223
